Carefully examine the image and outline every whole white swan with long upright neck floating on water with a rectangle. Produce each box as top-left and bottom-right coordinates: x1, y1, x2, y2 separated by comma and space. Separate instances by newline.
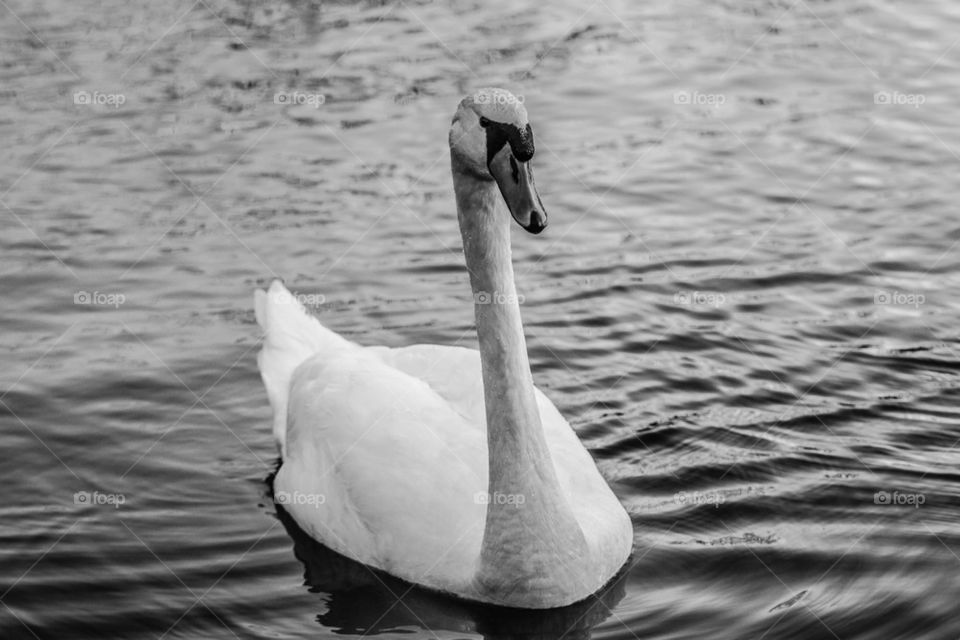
254, 88, 633, 609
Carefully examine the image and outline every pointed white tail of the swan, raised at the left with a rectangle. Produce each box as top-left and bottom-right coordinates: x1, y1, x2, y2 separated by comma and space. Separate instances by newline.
254, 280, 352, 452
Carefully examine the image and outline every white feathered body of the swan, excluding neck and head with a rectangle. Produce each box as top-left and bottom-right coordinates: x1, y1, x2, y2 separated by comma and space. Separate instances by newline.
256, 281, 631, 597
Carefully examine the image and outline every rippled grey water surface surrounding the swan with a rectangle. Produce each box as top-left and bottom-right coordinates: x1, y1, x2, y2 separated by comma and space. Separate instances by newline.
0, 0, 960, 639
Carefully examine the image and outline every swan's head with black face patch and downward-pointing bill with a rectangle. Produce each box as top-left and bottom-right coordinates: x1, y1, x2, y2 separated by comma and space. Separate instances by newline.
450, 88, 547, 233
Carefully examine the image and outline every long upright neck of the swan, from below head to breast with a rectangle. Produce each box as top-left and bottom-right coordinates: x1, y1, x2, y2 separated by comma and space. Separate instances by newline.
453, 156, 586, 604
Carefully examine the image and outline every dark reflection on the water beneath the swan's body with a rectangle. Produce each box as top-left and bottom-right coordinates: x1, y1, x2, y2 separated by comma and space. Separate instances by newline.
267, 474, 628, 640
